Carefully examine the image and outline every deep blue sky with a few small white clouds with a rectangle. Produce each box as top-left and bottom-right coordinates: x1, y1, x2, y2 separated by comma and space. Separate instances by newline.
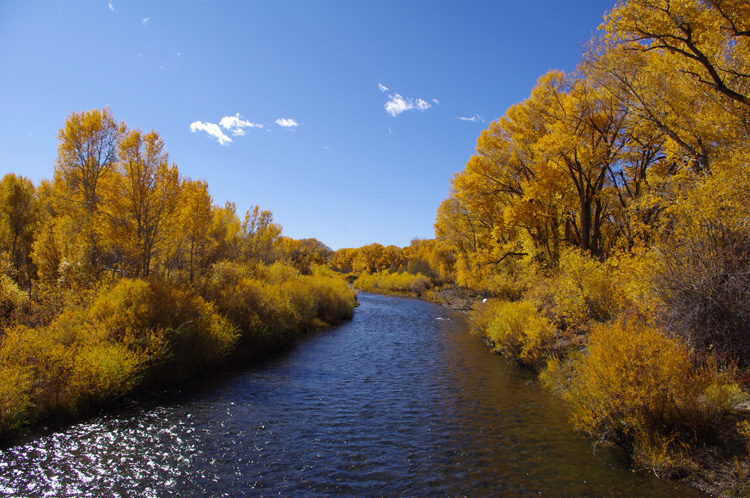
0, 0, 614, 249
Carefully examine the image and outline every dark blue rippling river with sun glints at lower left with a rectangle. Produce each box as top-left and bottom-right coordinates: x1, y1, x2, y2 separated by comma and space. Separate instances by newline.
0, 294, 705, 498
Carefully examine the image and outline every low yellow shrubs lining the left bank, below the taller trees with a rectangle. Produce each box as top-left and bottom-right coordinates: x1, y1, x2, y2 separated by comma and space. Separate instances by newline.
0, 263, 356, 438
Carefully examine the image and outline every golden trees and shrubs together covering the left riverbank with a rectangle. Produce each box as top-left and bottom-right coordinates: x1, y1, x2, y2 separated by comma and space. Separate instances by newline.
0, 108, 356, 438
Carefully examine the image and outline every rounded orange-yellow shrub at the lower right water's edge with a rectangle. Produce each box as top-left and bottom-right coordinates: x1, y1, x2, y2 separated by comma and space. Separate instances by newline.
542, 321, 742, 469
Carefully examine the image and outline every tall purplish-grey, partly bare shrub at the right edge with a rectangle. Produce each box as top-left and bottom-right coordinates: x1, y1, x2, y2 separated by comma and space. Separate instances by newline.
652, 165, 750, 365
